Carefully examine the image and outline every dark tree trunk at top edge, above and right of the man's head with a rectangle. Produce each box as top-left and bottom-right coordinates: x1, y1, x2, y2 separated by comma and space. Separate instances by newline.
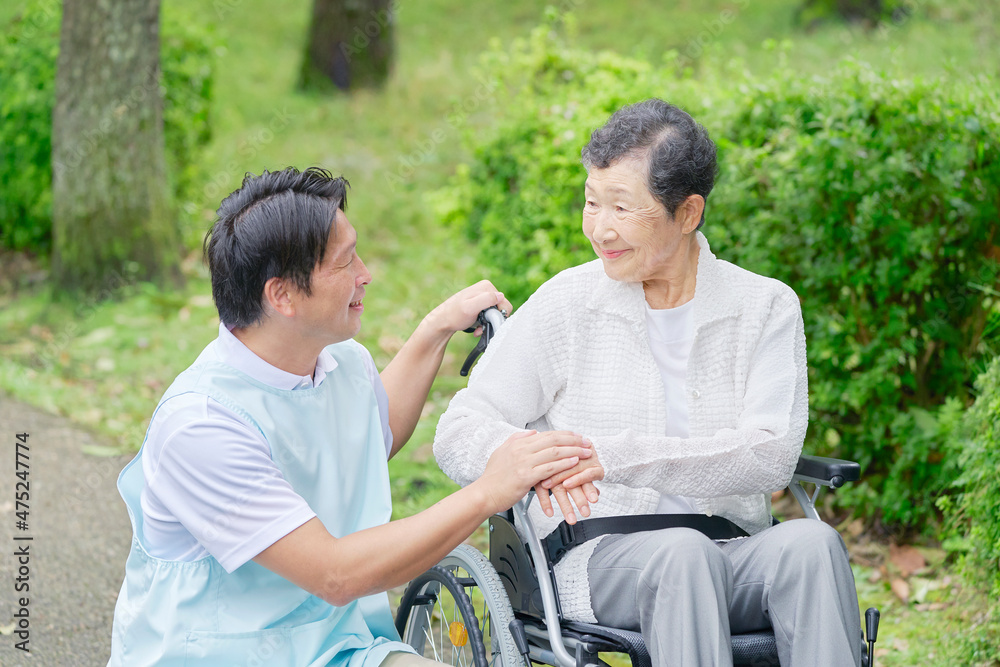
299, 0, 395, 90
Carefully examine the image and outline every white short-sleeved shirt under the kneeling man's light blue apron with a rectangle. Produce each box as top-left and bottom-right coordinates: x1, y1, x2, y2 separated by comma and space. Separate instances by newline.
140, 325, 392, 572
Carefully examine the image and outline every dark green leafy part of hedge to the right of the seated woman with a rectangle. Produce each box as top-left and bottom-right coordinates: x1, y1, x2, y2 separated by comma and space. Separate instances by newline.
711, 63, 1000, 528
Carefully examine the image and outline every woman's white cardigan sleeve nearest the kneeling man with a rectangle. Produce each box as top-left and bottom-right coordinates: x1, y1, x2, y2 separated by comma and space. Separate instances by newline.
434, 287, 559, 486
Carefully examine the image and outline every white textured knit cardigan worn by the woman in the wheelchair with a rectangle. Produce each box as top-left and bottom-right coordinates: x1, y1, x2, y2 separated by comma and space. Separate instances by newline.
434, 232, 808, 623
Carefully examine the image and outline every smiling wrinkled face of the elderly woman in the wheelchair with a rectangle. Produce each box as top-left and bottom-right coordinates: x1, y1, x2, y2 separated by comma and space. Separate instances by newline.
583, 158, 684, 282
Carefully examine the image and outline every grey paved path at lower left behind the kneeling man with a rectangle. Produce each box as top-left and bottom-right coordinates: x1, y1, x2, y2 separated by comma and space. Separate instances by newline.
0, 394, 132, 667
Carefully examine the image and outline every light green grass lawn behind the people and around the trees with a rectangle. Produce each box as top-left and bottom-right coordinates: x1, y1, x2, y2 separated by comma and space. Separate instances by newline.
0, 0, 1000, 667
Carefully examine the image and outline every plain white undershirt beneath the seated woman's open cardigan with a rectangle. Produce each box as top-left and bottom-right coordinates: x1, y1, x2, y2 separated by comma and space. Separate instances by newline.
646, 300, 696, 514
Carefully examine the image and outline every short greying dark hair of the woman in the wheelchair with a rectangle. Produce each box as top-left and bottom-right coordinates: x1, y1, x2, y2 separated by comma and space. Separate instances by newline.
582, 98, 717, 227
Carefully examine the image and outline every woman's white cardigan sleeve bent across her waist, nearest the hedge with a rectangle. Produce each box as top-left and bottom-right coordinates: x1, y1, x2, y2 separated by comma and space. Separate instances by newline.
591, 290, 808, 498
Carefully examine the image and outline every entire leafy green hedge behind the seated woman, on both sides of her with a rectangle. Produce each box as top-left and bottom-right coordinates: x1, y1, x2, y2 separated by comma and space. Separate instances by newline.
432, 26, 1000, 532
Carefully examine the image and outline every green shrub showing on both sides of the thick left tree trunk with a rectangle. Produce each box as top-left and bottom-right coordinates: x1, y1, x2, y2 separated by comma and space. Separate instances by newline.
0, 0, 213, 254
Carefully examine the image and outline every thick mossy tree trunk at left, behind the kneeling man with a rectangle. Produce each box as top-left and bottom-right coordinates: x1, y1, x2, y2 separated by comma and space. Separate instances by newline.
52, 0, 179, 296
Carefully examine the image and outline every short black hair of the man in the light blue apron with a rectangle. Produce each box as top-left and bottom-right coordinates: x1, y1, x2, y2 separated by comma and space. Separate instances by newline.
204, 167, 350, 328
